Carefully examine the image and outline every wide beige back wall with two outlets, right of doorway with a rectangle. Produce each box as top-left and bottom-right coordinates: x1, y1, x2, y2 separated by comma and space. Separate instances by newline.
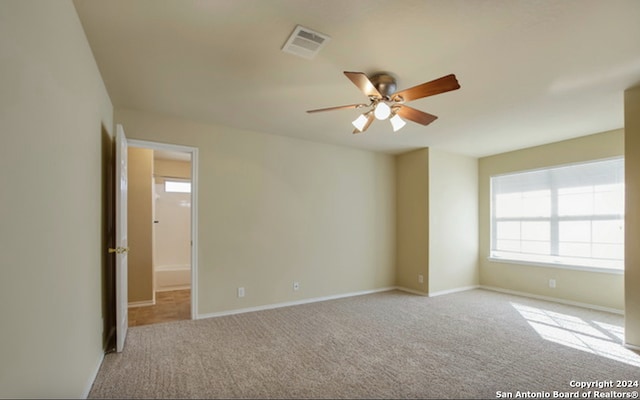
116, 110, 395, 315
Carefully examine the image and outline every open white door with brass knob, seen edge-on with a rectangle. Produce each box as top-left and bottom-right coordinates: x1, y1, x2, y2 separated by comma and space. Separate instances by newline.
109, 125, 129, 352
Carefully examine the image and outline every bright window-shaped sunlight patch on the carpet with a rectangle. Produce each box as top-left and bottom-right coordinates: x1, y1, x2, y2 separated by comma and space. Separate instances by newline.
511, 302, 640, 367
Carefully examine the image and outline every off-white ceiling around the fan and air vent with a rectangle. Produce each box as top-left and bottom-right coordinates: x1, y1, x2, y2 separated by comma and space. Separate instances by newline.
75, 0, 640, 157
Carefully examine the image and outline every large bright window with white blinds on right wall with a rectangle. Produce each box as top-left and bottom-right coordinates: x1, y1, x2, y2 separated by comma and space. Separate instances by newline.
490, 158, 624, 270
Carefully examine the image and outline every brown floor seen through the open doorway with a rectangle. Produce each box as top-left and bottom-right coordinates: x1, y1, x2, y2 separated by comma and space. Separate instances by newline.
129, 289, 191, 326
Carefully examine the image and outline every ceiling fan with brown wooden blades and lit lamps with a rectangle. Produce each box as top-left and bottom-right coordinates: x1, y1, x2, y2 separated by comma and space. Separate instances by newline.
307, 71, 460, 133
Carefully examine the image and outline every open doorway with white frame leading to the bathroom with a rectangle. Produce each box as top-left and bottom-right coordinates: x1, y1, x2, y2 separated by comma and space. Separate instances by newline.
128, 140, 197, 327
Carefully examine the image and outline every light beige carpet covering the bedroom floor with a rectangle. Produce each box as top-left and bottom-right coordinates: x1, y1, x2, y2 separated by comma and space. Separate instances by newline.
89, 289, 640, 399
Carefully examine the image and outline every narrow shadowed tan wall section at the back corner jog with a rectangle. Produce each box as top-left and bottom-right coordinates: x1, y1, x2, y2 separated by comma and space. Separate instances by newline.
395, 149, 429, 294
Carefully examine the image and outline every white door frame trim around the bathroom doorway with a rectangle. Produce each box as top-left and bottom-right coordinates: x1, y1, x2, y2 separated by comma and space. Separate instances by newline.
127, 139, 198, 319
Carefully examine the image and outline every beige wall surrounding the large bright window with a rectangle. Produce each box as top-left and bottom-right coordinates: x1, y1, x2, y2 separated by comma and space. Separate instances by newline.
478, 130, 624, 310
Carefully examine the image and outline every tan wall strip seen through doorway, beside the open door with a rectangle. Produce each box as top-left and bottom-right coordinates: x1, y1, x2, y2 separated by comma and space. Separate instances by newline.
125, 148, 154, 303
